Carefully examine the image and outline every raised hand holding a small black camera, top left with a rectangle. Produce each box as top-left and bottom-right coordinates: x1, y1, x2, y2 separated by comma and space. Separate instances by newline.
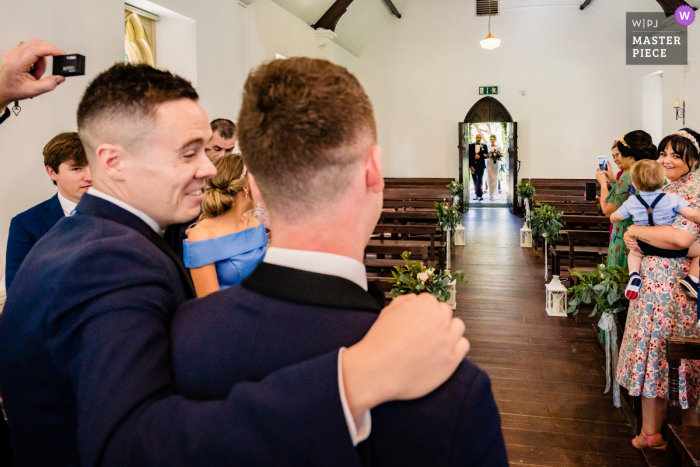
0, 39, 66, 111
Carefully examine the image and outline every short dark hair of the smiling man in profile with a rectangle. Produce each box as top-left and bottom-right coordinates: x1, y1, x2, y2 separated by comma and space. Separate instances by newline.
78, 63, 199, 155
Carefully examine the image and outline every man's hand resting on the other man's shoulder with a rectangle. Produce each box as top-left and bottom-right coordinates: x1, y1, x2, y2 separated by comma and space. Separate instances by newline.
343, 294, 469, 417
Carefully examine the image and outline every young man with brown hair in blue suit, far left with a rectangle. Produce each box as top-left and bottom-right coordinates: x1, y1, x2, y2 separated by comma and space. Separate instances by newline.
5, 133, 92, 290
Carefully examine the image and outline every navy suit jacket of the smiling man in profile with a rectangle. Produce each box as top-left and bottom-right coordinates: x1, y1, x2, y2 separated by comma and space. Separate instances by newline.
0, 194, 360, 467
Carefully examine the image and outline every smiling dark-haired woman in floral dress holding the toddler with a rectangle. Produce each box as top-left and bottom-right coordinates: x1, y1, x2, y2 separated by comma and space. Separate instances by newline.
617, 129, 700, 449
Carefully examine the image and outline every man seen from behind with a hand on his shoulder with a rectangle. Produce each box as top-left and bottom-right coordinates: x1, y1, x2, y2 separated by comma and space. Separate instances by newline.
171, 58, 508, 467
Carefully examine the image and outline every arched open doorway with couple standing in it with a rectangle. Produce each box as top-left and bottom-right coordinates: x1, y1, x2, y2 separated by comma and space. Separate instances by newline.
459, 97, 518, 211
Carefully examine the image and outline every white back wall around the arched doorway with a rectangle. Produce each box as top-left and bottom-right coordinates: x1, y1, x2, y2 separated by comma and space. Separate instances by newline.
358, 0, 644, 178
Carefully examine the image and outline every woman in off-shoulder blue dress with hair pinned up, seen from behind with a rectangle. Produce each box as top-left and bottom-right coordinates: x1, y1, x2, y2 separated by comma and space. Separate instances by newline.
183, 154, 267, 297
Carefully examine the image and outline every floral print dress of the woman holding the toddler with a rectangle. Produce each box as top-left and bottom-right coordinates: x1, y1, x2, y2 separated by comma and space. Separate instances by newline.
617, 173, 700, 411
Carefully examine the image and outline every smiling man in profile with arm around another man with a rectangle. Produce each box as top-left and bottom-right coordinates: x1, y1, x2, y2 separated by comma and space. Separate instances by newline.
0, 63, 468, 467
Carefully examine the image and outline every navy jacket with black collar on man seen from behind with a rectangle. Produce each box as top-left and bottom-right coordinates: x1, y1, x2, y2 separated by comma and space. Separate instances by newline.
171, 263, 508, 467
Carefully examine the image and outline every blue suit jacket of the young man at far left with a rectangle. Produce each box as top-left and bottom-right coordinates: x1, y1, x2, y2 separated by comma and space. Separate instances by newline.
5, 194, 64, 290
